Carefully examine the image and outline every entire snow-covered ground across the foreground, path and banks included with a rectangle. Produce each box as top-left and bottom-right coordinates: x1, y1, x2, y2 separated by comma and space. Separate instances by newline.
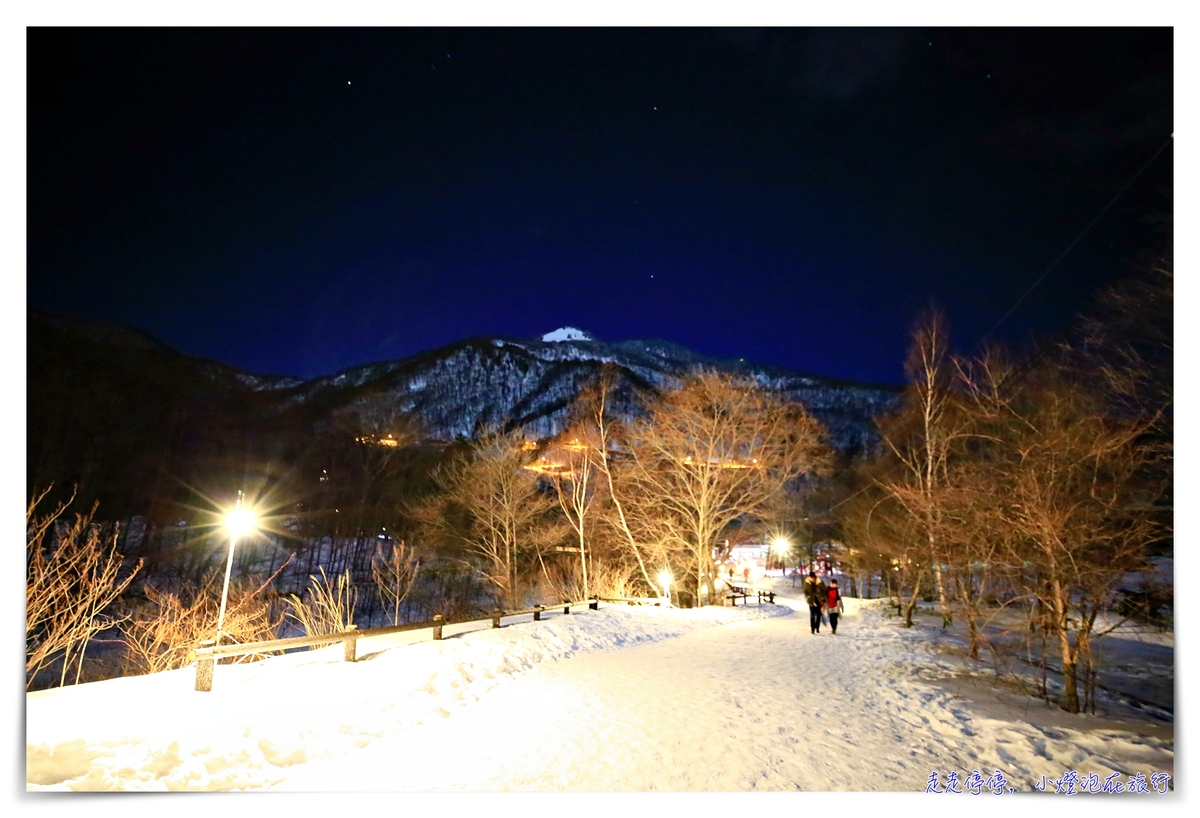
25, 582, 1175, 798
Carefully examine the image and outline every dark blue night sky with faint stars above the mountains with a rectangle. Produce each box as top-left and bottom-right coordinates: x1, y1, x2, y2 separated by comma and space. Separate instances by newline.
28, 28, 1174, 383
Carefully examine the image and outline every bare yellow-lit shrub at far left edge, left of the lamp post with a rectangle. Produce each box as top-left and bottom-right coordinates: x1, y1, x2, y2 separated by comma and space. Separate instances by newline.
25, 488, 142, 688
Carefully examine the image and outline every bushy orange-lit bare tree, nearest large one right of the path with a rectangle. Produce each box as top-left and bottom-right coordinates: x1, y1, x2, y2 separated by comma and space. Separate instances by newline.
955, 361, 1164, 712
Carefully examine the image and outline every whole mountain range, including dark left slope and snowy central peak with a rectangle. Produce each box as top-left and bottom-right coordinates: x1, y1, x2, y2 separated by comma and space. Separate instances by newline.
26, 311, 899, 486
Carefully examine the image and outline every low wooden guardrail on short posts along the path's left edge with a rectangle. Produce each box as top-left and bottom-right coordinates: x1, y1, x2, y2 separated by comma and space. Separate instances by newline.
192, 597, 604, 691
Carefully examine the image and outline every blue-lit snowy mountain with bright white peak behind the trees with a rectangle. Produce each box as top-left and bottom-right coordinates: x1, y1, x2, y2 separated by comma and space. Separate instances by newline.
281, 327, 899, 452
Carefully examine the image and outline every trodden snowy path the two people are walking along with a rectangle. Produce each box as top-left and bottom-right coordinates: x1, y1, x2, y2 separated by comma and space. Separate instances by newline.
292, 594, 945, 792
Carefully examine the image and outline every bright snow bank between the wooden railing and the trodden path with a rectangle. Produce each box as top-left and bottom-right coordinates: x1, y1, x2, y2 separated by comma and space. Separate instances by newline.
25, 606, 788, 790
